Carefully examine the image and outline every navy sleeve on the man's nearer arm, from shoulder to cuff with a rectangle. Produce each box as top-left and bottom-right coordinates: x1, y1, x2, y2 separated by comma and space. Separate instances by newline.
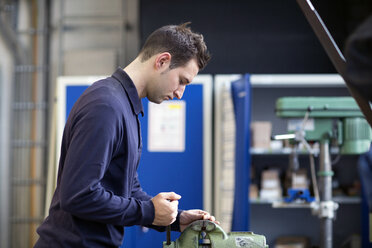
59, 103, 154, 226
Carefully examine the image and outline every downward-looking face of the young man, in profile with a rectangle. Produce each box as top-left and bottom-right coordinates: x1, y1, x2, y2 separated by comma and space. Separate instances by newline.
147, 59, 199, 103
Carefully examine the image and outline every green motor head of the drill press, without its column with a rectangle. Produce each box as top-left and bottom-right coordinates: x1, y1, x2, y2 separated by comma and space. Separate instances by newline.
276, 97, 372, 154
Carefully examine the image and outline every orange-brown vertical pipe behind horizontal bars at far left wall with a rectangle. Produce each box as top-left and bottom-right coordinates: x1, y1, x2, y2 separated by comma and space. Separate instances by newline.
29, 0, 48, 247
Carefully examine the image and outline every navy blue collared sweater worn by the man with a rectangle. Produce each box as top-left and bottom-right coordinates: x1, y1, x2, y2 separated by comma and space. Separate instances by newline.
35, 68, 179, 247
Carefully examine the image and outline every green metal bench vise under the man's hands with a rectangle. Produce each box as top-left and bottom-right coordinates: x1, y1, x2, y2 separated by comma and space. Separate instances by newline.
163, 220, 269, 248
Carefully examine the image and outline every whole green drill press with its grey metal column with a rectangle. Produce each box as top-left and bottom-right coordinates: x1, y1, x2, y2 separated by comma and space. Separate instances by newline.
276, 97, 372, 247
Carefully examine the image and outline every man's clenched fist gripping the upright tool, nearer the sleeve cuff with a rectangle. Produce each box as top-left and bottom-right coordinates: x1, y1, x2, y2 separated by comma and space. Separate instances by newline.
151, 192, 181, 226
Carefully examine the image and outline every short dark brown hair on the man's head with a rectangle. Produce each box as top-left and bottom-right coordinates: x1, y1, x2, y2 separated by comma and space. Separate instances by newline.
140, 22, 210, 70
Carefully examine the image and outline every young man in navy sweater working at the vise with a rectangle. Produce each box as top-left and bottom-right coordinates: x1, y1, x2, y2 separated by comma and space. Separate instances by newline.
35, 23, 215, 247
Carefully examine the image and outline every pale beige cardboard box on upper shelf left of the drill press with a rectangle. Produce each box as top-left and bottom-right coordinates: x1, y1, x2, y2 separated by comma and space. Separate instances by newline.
251, 121, 272, 148
